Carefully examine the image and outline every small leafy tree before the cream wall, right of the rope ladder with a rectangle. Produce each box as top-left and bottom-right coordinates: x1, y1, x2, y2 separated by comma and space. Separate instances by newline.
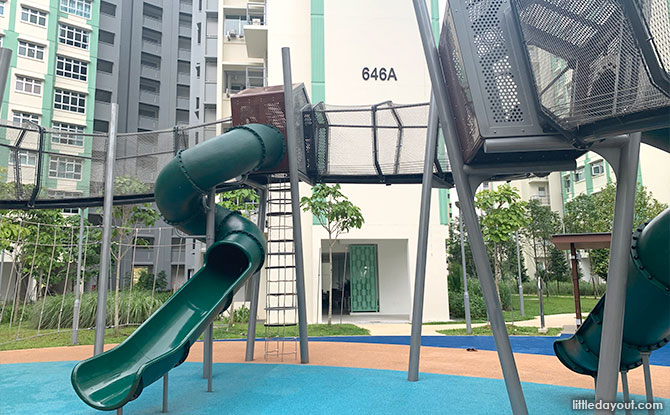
300, 183, 365, 326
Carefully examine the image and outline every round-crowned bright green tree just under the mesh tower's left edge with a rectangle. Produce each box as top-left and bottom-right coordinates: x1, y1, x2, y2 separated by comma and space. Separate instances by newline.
475, 184, 528, 288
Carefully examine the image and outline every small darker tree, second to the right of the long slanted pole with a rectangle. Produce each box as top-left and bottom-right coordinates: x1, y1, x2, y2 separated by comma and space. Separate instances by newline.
522, 200, 561, 296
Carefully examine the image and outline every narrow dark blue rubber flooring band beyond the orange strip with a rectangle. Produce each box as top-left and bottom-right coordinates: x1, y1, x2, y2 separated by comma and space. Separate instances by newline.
221, 334, 670, 366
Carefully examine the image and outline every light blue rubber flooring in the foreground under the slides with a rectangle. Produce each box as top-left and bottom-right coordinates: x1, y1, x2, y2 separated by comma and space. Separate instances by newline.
0, 362, 670, 415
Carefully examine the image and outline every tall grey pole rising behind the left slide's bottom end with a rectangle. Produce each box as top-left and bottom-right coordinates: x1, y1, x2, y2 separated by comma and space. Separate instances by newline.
93, 103, 118, 355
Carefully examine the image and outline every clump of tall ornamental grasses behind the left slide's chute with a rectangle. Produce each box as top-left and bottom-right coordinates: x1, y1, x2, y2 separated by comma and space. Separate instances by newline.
30, 290, 171, 329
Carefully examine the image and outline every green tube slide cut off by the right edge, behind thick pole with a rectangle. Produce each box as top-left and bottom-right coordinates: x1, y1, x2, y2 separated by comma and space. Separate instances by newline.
554, 209, 670, 377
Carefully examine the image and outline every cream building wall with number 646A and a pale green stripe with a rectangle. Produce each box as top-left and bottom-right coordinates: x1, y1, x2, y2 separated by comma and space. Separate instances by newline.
268, 0, 449, 322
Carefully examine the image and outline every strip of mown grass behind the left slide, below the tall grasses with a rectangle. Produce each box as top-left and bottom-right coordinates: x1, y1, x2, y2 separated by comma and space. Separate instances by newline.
0, 322, 370, 350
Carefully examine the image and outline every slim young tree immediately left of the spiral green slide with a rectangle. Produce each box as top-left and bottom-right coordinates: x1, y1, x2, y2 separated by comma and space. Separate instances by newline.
109, 176, 160, 335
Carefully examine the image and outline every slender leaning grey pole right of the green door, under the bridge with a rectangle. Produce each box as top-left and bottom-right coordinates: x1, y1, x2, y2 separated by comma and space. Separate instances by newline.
407, 97, 437, 382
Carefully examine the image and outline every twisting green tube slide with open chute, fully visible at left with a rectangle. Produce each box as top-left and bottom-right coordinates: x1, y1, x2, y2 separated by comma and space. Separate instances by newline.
71, 124, 285, 410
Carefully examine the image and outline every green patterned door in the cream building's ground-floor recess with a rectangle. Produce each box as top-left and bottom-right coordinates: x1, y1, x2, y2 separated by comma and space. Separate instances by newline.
349, 245, 379, 312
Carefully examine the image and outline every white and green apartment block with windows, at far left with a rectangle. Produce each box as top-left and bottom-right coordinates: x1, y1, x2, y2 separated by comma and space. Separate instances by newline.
0, 0, 99, 197
